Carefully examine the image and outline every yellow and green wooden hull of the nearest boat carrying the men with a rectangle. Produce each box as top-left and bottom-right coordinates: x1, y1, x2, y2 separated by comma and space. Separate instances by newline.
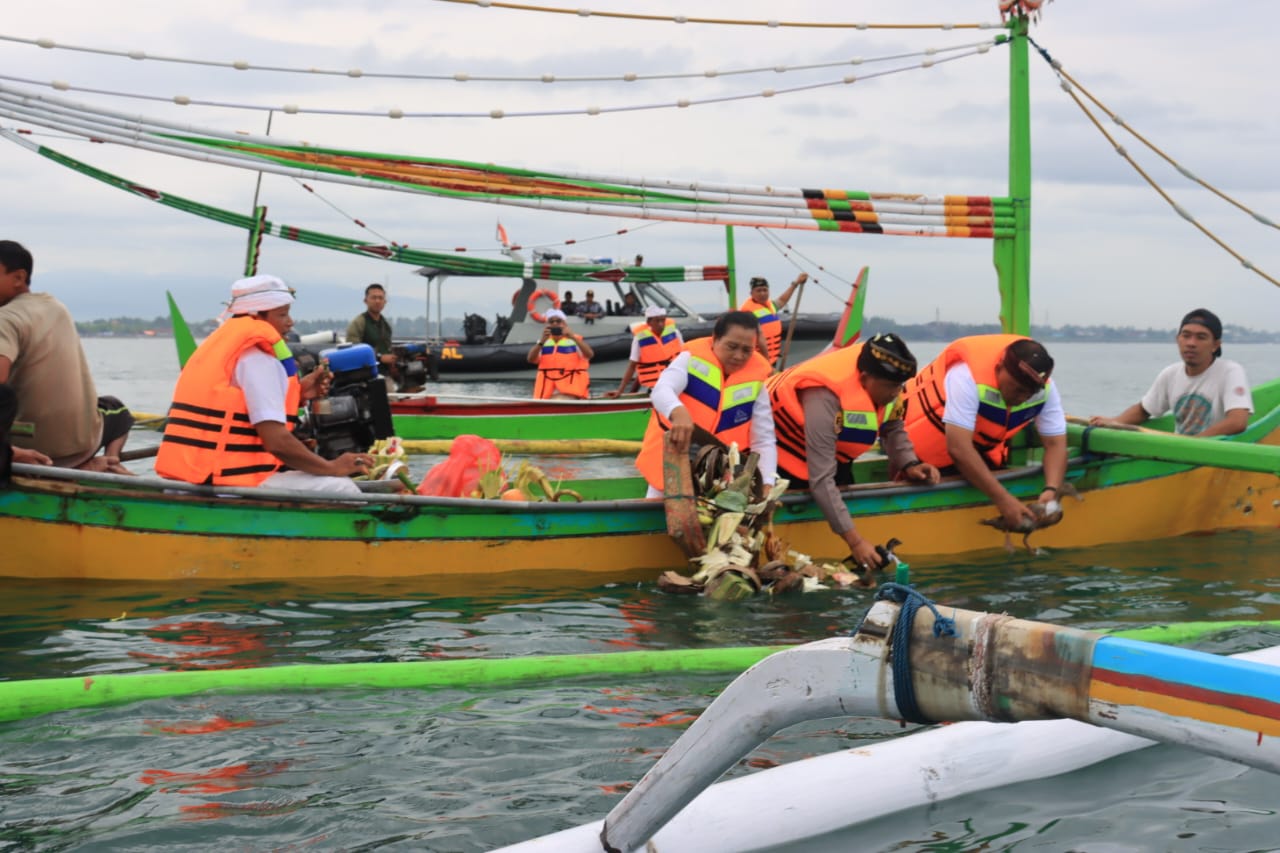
0, 380, 1280, 580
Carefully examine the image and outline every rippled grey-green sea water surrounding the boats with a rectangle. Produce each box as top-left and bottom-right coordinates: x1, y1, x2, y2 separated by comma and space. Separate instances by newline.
0, 339, 1280, 852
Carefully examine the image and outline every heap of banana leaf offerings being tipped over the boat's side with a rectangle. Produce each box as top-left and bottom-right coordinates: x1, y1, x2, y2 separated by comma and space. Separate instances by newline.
658, 444, 864, 601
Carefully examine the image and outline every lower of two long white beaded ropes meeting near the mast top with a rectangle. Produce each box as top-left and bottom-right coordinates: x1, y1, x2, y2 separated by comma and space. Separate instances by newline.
0, 44, 991, 119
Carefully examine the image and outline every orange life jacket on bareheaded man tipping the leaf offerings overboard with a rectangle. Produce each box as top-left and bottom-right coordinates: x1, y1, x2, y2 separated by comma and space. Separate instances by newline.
636, 338, 773, 489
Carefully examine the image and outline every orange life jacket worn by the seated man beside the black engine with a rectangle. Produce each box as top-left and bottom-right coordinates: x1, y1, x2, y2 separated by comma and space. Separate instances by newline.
156, 316, 302, 485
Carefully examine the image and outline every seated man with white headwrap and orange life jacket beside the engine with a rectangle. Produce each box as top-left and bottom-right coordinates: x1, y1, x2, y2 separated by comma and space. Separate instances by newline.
156, 275, 374, 494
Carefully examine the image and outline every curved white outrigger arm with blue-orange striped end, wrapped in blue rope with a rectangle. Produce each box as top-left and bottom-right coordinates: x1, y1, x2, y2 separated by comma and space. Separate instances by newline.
598, 588, 1280, 853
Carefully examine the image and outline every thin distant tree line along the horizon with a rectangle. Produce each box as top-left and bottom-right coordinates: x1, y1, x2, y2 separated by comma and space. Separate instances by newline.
76, 316, 1280, 343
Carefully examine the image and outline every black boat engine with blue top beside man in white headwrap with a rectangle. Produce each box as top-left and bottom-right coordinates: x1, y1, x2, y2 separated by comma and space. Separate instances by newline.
306, 343, 396, 459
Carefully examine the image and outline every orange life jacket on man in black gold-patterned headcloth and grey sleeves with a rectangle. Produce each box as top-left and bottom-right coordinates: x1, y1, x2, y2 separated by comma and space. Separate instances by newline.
768, 343, 893, 480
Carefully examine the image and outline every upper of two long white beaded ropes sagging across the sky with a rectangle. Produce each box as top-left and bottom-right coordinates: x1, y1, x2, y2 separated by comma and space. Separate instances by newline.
0, 33, 996, 86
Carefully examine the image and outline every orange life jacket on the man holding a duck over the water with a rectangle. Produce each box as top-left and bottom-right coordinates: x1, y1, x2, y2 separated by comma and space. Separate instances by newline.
904, 334, 1046, 467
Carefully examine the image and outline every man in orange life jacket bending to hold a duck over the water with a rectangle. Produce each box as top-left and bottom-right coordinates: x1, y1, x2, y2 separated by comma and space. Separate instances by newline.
906, 334, 1066, 529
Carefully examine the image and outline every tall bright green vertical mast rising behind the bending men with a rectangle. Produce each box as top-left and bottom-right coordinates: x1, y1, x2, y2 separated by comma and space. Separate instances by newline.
992, 15, 1032, 334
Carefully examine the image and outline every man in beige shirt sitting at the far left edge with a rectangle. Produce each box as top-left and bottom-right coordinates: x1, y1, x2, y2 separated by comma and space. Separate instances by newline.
0, 240, 133, 474
